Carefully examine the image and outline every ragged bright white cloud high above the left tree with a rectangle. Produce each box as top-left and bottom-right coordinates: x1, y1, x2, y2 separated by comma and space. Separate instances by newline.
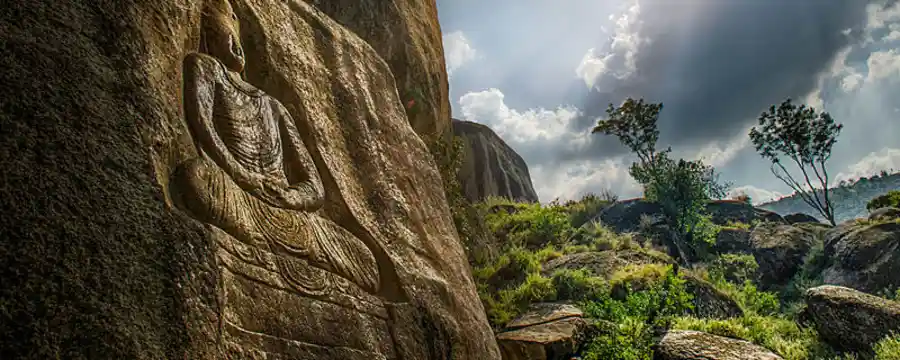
575, 0, 649, 87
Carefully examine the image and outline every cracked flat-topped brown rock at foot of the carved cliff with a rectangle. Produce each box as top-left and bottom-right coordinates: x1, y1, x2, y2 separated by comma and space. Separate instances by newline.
497, 303, 588, 360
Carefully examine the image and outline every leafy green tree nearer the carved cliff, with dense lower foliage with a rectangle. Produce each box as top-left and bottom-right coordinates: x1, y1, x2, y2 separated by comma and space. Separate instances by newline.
591, 98, 727, 262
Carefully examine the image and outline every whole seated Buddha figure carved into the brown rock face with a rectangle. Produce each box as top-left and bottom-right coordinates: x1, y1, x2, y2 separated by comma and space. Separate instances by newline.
173, 0, 380, 293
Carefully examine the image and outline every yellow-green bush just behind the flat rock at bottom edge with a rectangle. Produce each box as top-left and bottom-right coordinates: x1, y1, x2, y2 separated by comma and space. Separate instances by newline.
672, 314, 834, 360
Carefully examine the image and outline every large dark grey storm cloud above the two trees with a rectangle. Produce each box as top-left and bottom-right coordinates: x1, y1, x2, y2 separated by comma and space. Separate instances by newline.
563, 0, 867, 159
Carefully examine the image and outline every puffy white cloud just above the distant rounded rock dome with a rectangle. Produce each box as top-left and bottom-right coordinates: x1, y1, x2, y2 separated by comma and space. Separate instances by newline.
459, 88, 590, 146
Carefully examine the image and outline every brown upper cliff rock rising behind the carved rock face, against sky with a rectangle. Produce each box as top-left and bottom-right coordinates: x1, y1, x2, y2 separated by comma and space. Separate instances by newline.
305, 0, 451, 139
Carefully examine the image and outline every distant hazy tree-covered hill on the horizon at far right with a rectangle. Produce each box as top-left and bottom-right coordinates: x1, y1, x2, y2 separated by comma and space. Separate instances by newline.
758, 173, 900, 222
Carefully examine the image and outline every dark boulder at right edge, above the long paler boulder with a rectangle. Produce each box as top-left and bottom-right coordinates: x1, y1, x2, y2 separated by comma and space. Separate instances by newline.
822, 222, 900, 292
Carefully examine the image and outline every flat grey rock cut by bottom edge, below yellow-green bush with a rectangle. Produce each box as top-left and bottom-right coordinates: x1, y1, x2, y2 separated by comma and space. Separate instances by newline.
653, 330, 782, 360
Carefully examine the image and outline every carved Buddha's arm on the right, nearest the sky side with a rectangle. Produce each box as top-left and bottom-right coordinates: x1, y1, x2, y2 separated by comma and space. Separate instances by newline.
273, 101, 325, 211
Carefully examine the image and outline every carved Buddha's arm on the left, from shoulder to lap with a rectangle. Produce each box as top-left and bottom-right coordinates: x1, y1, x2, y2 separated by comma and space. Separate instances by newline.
184, 53, 261, 188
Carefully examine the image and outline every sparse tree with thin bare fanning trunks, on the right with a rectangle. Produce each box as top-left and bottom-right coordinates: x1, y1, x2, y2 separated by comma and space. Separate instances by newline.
750, 99, 843, 225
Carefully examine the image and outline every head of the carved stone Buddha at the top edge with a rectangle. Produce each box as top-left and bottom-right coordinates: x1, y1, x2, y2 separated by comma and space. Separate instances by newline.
203, 0, 244, 72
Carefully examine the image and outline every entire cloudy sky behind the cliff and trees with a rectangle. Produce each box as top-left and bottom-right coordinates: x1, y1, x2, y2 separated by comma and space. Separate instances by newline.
437, 0, 900, 203
